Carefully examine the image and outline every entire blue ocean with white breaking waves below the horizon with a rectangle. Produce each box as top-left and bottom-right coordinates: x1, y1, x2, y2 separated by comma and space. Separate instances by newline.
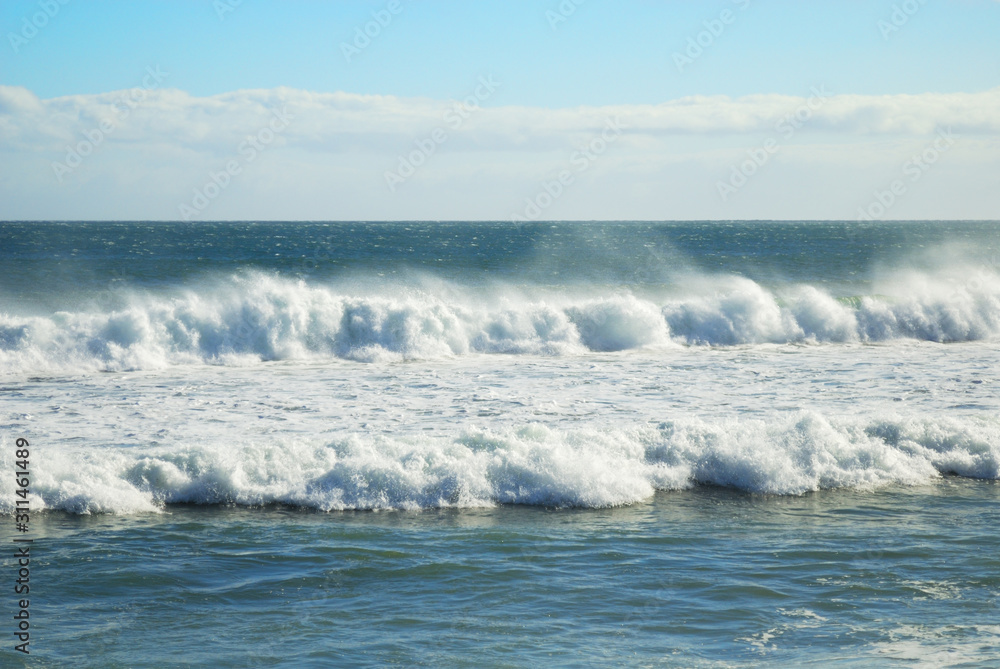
0, 221, 1000, 667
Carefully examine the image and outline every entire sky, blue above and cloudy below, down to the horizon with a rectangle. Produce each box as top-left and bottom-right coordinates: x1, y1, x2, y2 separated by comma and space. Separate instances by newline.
0, 0, 1000, 221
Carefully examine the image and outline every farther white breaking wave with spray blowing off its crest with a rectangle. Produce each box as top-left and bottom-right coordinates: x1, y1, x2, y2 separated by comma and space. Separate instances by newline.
0, 274, 1000, 373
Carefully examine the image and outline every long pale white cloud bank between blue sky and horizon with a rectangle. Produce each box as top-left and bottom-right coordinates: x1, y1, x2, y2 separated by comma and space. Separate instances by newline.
0, 86, 1000, 219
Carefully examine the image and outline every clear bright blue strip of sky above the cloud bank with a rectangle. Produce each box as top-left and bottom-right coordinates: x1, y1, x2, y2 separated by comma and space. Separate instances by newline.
0, 0, 1000, 107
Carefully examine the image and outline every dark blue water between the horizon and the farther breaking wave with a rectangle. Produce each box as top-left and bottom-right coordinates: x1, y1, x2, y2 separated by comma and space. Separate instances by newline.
0, 221, 1000, 304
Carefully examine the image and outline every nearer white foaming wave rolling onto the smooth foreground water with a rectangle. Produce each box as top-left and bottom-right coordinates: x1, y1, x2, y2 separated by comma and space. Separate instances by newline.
0, 412, 1000, 514
